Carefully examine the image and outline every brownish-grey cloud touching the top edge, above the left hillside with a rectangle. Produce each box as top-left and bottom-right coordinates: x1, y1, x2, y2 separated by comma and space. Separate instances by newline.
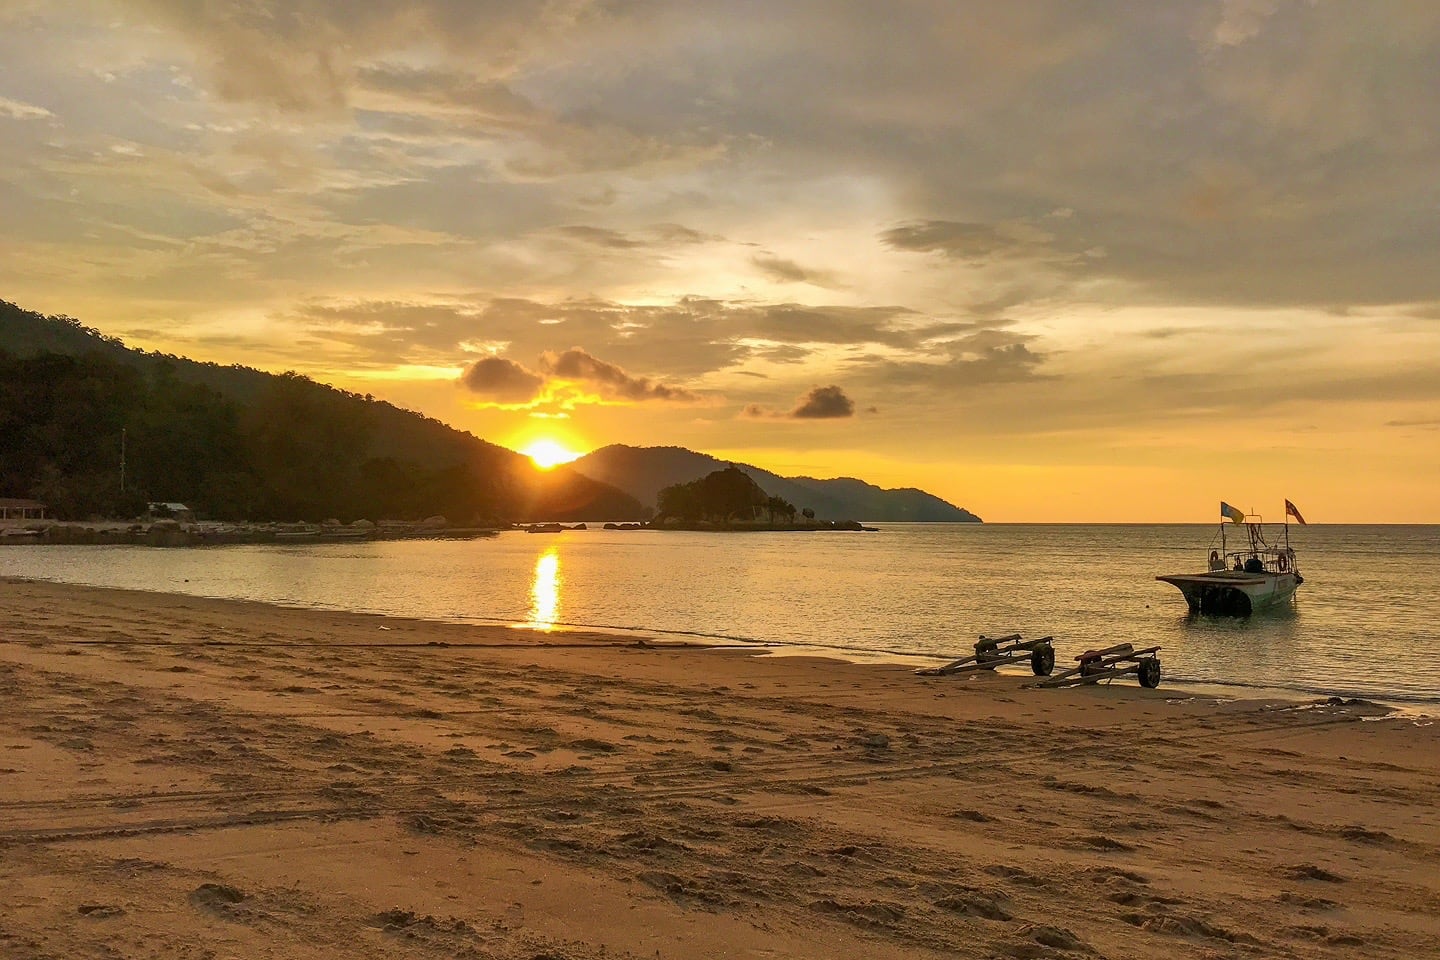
104, 0, 724, 181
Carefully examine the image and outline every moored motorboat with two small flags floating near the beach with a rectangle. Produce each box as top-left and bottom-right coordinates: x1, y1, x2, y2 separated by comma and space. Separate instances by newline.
1155, 501, 1305, 617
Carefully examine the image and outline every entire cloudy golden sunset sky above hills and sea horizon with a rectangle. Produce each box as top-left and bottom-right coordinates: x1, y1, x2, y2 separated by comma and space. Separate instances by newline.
0, 0, 1440, 522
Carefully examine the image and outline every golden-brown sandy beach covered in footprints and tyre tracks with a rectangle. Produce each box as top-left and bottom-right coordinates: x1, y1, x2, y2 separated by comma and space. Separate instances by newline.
0, 580, 1440, 960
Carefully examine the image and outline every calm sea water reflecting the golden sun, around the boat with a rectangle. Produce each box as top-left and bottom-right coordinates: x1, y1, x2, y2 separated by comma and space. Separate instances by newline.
0, 524, 1440, 704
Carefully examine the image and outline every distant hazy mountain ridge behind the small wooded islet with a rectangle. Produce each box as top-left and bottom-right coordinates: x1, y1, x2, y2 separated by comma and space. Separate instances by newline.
570, 443, 981, 524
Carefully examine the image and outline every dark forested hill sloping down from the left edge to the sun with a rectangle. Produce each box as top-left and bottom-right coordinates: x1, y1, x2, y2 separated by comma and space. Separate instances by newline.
0, 301, 644, 525
